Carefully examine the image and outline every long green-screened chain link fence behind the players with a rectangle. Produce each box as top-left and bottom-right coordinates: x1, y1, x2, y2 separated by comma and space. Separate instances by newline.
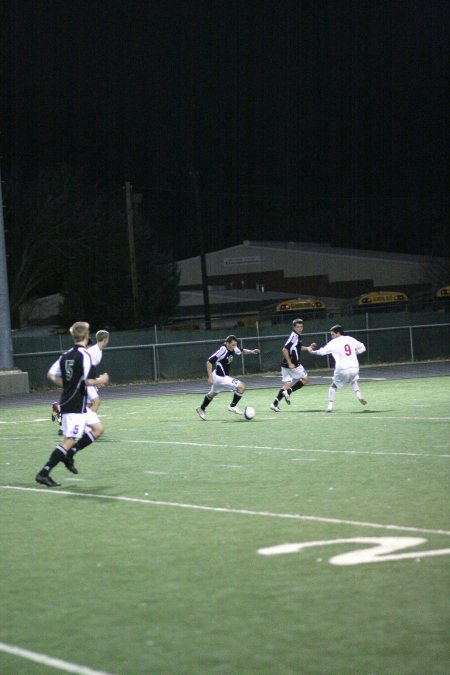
10, 323, 450, 389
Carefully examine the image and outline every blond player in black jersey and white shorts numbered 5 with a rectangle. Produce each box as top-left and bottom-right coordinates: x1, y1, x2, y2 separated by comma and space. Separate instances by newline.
36, 321, 109, 487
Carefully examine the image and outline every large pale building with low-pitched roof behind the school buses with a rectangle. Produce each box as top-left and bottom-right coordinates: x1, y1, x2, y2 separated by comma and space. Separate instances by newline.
179, 241, 450, 298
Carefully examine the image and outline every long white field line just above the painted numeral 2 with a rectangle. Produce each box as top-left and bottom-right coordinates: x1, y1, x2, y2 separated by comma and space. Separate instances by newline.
0, 485, 450, 536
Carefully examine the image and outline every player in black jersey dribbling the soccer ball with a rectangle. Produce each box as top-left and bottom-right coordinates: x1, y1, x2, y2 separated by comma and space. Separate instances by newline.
196, 335, 260, 420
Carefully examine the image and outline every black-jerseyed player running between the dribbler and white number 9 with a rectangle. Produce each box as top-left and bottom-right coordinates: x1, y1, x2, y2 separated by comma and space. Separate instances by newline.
270, 319, 317, 412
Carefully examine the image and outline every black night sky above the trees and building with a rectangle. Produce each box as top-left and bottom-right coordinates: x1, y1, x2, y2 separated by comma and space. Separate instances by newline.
0, 0, 450, 259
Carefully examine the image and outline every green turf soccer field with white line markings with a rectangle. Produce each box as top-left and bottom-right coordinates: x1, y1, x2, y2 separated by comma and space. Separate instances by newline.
0, 377, 450, 675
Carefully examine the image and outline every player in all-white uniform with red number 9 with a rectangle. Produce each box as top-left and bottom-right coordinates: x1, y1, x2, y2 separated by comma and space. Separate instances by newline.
308, 325, 367, 412
